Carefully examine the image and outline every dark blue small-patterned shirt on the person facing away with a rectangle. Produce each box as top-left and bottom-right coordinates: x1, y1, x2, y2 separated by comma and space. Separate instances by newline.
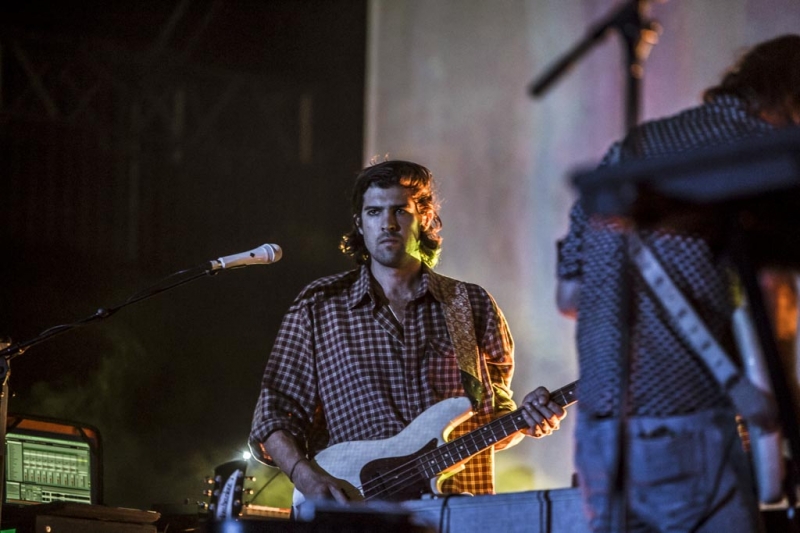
558, 96, 773, 417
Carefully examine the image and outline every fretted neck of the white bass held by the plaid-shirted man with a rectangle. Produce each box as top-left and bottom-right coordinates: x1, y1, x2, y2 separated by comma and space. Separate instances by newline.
419, 381, 578, 479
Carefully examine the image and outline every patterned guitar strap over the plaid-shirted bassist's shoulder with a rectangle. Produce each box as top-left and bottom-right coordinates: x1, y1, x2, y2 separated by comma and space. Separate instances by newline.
439, 276, 483, 411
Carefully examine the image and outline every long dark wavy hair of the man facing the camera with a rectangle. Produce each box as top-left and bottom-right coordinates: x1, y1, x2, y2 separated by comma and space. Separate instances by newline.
339, 161, 442, 268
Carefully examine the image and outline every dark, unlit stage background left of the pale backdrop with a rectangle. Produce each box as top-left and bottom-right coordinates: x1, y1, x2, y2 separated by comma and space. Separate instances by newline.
0, 0, 366, 508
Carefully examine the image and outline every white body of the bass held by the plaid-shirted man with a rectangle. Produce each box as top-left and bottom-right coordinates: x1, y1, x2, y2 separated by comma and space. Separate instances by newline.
292, 397, 473, 508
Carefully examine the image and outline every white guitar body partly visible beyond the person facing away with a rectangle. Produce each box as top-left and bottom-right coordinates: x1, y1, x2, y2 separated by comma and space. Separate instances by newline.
733, 306, 785, 503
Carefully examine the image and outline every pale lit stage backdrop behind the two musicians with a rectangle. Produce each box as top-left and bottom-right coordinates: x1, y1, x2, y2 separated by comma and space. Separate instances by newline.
364, 0, 800, 492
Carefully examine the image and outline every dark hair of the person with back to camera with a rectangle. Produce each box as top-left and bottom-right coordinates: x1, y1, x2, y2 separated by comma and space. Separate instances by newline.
703, 34, 800, 124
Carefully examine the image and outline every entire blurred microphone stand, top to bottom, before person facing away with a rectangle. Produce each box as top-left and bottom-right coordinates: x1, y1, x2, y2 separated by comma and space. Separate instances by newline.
528, 0, 660, 531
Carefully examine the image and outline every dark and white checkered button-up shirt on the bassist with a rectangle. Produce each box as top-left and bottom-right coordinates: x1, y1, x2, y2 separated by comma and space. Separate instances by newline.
250, 266, 515, 494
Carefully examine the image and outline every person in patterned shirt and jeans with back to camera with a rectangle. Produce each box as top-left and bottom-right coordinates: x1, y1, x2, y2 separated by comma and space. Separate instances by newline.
556, 35, 800, 533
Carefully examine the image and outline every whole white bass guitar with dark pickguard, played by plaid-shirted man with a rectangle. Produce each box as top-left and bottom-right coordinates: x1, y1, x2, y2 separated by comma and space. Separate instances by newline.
293, 381, 578, 508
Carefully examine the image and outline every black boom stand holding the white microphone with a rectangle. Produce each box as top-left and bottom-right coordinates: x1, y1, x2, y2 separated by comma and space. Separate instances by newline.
0, 262, 225, 524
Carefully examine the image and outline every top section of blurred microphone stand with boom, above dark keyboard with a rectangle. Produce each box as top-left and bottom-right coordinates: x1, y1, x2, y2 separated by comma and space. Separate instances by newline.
528, 0, 660, 130
